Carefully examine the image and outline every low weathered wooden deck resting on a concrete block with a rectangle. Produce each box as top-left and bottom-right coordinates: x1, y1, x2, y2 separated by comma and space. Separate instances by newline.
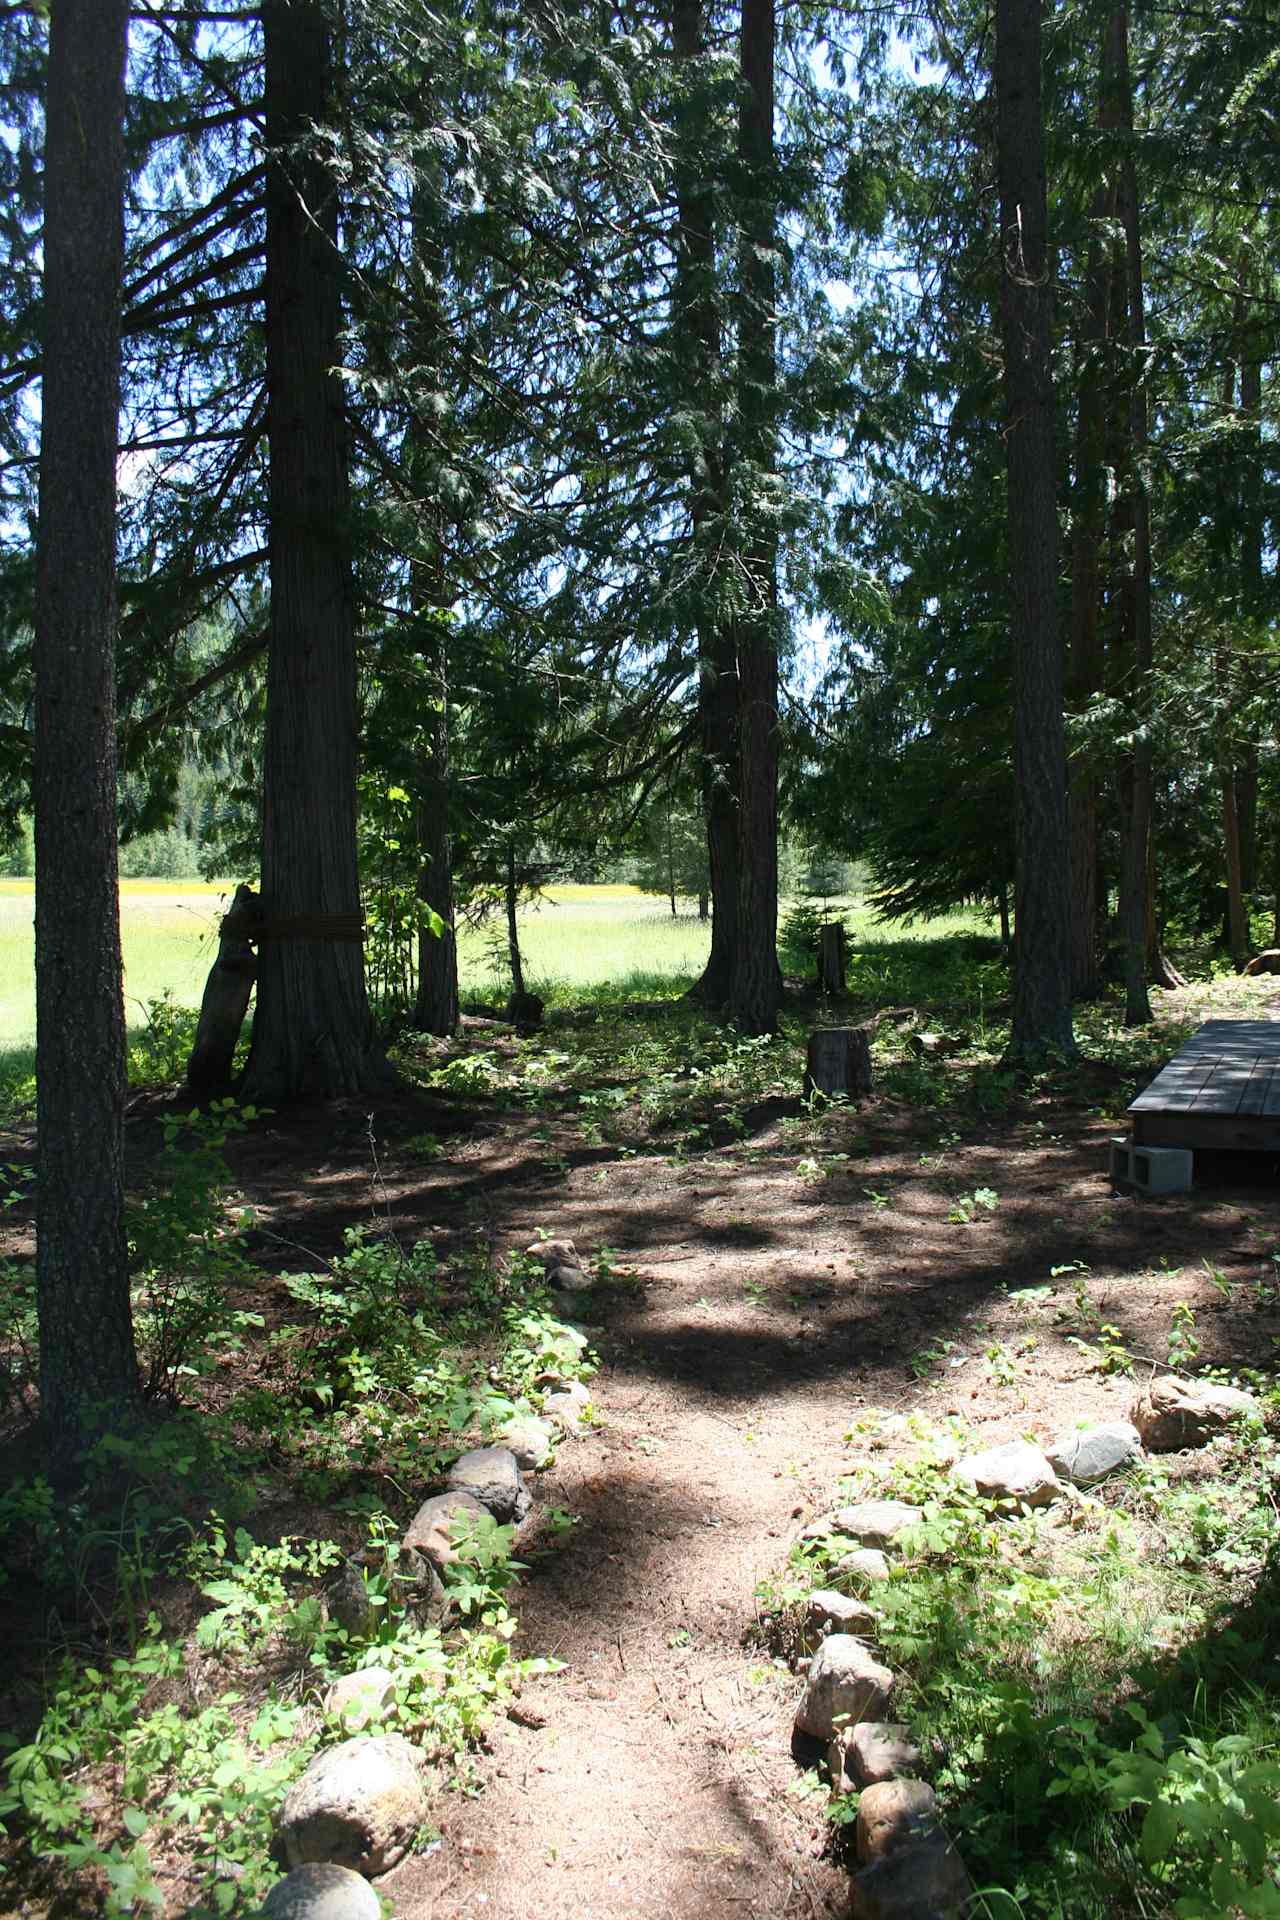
1128, 1020, 1280, 1152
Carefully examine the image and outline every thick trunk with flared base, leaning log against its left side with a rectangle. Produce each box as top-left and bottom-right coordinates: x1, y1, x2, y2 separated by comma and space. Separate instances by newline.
244, 0, 388, 1106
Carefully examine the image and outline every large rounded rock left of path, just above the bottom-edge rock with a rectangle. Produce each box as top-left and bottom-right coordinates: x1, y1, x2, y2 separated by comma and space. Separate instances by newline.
276, 1734, 426, 1878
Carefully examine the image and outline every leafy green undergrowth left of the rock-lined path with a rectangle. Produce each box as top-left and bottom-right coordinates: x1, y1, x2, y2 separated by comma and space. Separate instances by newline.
0, 1106, 591, 1920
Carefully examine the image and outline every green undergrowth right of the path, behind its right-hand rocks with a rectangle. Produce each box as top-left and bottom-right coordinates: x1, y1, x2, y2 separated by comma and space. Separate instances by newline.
760, 1377, 1280, 1920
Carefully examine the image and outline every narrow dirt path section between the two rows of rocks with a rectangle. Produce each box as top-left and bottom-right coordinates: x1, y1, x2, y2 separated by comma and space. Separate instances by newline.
384, 1297, 855, 1920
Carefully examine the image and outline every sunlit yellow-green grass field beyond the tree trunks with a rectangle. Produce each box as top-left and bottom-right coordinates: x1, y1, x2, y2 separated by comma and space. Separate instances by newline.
0, 879, 986, 1066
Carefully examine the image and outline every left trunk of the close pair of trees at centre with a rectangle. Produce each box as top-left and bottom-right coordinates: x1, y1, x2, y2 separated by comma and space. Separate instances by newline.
672, 0, 739, 1008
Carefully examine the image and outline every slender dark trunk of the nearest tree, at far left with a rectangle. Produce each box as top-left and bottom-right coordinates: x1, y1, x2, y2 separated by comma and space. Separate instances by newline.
33, 0, 138, 1482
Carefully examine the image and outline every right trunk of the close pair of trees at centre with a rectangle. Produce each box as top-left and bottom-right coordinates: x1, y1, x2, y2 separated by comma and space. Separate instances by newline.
729, 0, 783, 1033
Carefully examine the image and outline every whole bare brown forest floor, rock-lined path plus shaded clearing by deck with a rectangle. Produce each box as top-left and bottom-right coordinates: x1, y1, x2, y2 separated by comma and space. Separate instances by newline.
6, 960, 1280, 1920
